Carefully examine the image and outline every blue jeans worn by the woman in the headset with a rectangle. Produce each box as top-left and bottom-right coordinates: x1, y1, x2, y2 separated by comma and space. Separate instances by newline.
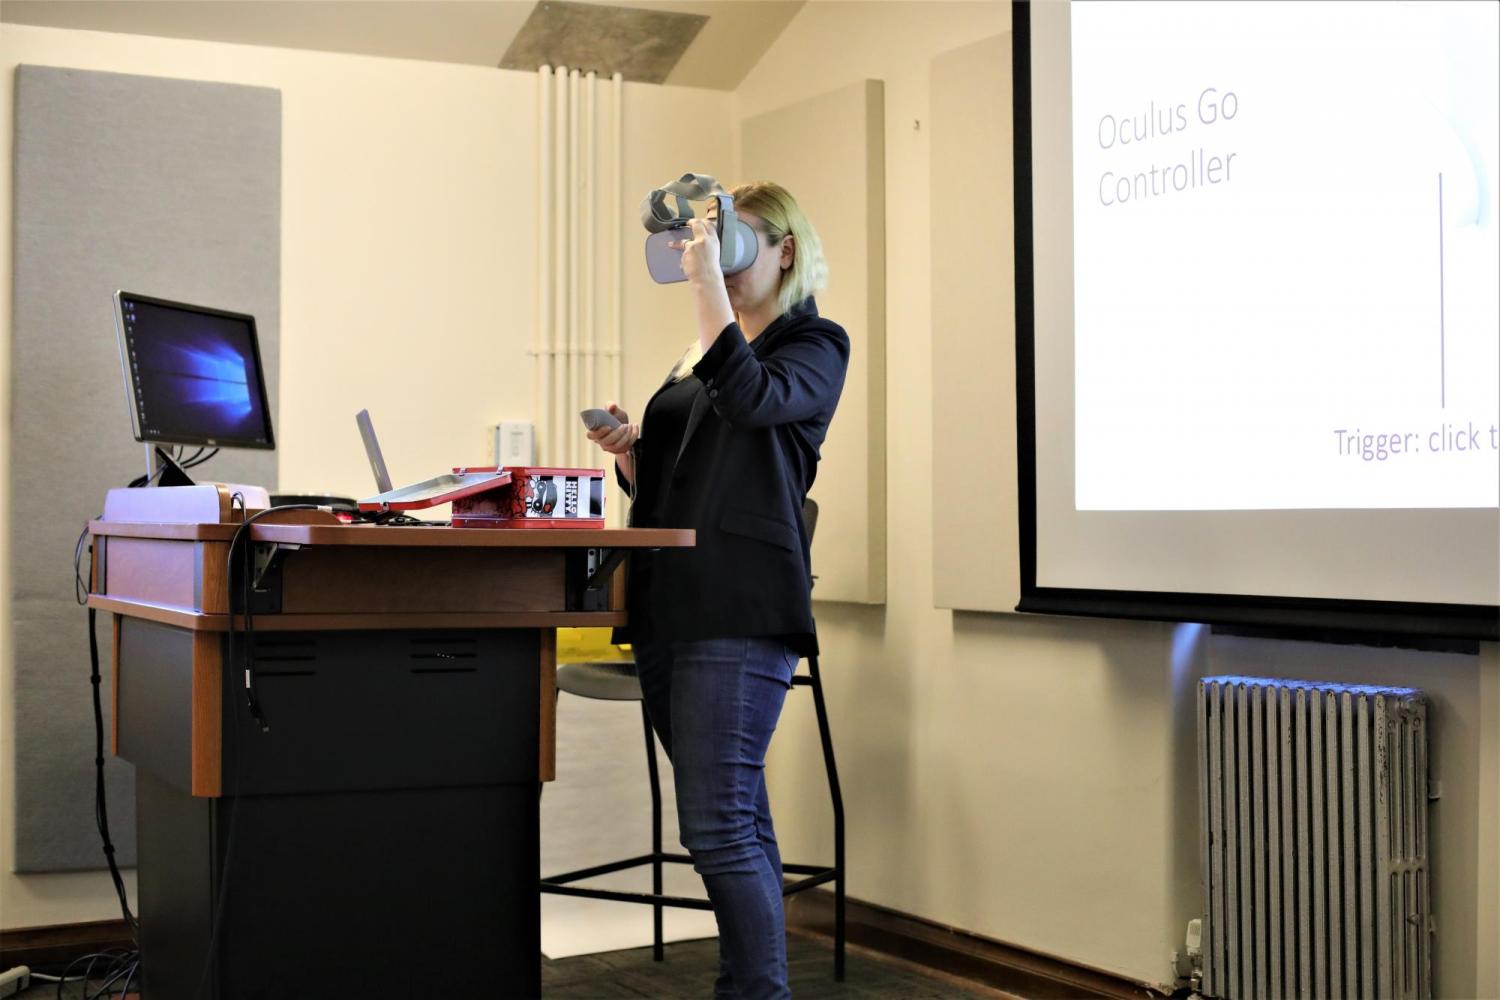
635, 639, 798, 1000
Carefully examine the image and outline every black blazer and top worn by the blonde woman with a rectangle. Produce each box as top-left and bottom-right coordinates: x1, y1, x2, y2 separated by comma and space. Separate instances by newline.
618, 298, 849, 655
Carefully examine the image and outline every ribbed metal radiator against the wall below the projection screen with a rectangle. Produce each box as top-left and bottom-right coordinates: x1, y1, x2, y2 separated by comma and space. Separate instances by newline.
1197, 678, 1433, 1000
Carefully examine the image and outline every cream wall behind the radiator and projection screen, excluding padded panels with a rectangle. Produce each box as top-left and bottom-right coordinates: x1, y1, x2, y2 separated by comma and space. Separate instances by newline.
737, 0, 1500, 997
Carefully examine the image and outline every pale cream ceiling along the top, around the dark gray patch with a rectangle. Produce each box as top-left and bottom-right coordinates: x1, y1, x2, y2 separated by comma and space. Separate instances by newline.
0, 0, 806, 90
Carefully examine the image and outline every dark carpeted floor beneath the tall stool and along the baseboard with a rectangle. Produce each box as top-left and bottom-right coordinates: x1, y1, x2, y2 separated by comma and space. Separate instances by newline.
18, 934, 1007, 1000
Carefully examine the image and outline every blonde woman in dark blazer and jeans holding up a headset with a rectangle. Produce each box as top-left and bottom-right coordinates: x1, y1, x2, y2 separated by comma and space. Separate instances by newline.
590, 183, 849, 1000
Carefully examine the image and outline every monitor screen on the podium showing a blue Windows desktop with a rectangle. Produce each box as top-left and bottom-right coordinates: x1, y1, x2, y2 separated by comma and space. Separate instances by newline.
114, 292, 275, 448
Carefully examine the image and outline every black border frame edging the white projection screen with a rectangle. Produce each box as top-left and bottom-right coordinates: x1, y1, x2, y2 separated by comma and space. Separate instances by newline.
1011, 0, 1500, 645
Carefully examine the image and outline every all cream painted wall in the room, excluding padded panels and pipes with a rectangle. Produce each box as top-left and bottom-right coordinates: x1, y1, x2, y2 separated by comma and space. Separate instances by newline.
0, 7, 1500, 997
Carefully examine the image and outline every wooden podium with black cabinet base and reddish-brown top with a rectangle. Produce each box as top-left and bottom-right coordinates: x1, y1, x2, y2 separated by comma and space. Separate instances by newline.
89, 487, 693, 1000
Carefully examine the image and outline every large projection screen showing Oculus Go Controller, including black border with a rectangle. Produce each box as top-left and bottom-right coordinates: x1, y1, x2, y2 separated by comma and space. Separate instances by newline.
1014, 0, 1500, 639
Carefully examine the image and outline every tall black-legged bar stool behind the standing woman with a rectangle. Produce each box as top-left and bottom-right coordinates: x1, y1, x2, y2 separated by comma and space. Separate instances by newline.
542, 501, 845, 982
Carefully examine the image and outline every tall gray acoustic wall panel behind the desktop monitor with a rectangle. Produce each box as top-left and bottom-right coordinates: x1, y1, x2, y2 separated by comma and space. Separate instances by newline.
11, 66, 281, 871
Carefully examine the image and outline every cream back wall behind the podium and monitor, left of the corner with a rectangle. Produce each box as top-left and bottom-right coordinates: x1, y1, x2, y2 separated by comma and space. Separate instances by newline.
0, 24, 735, 928
